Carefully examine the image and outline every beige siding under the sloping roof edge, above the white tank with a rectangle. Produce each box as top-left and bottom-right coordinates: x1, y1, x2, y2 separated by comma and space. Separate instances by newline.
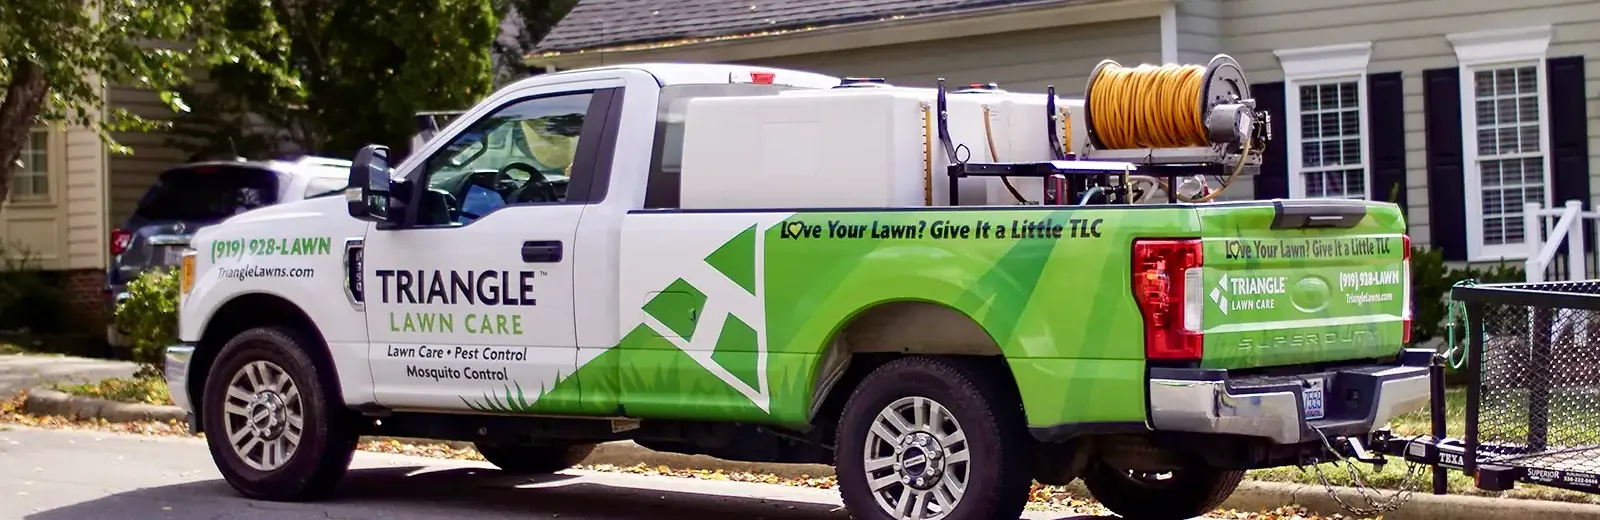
736, 18, 1162, 96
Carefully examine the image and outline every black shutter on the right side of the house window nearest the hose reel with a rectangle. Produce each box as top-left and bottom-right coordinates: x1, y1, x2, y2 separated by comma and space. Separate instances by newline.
1366, 72, 1411, 216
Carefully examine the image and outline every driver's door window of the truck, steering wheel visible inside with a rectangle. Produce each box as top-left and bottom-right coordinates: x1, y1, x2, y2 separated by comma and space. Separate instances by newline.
418, 93, 594, 226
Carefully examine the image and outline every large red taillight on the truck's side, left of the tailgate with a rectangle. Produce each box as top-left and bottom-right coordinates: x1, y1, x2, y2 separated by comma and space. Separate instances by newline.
1133, 240, 1205, 360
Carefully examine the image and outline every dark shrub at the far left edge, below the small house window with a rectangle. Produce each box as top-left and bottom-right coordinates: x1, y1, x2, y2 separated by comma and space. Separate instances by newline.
0, 243, 67, 333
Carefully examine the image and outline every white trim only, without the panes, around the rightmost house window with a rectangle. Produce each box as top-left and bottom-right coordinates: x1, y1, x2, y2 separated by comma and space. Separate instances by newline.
1445, 24, 1555, 261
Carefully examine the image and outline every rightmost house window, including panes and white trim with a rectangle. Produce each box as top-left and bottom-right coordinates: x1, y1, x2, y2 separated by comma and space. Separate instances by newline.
1448, 26, 1552, 261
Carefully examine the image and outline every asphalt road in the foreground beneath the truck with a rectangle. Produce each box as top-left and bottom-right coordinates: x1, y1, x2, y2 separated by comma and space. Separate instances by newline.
0, 426, 1113, 520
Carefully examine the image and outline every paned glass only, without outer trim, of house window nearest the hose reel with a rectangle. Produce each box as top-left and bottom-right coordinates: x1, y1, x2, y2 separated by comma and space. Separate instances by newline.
1296, 80, 1366, 198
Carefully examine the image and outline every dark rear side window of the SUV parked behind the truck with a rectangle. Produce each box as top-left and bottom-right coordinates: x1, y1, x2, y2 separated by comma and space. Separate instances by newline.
134, 165, 278, 221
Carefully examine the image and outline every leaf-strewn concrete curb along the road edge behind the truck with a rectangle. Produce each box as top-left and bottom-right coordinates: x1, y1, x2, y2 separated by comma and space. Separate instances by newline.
22, 401, 1600, 520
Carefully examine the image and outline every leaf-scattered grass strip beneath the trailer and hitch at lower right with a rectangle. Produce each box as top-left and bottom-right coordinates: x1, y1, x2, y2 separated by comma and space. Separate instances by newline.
1250, 387, 1600, 504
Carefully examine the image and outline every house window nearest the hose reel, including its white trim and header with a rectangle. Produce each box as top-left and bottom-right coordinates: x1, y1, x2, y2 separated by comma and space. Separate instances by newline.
1275, 42, 1373, 198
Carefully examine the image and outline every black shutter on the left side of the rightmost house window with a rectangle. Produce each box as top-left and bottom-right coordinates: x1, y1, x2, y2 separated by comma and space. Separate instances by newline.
1422, 67, 1467, 261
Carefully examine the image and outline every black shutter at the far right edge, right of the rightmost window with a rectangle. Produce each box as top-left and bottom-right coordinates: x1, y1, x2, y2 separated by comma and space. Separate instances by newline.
1546, 56, 1592, 210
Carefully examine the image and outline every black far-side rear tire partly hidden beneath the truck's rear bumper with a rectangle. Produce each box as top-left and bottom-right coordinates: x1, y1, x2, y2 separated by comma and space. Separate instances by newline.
1083, 462, 1245, 520
